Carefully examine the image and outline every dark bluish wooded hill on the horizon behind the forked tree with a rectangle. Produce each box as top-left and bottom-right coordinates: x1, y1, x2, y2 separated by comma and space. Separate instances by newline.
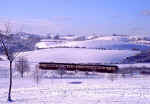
0, 33, 40, 54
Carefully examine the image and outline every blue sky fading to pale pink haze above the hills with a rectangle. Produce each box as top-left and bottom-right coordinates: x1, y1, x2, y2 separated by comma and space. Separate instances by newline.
0, 0, 150, 35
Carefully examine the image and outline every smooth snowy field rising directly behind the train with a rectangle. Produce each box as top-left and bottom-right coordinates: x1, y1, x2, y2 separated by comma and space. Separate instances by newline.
17, 48, 138, 64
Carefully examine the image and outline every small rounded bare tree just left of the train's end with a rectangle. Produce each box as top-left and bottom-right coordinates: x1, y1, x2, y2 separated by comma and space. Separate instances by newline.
15, 56, 30, 78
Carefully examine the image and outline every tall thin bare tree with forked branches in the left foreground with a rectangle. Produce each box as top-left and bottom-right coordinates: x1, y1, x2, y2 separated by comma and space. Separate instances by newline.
0, 22, 34, 102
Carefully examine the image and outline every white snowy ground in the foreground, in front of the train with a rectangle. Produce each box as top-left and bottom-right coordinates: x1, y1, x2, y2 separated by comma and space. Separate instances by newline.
0, 74, 150, 104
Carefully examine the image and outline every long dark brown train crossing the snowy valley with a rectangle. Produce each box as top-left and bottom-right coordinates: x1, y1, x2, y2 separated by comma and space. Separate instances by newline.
39, 62, 118, 73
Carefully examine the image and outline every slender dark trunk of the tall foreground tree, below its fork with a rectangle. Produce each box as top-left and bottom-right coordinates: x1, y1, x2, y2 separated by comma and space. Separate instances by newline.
8, 61, 12, 101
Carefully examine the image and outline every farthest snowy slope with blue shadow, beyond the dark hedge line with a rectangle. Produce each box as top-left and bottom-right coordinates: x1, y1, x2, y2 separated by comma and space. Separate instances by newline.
36, 36, 150, 50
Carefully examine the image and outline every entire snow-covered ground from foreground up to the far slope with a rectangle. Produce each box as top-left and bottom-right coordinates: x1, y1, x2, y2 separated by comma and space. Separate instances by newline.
0, 36, 150, 104
